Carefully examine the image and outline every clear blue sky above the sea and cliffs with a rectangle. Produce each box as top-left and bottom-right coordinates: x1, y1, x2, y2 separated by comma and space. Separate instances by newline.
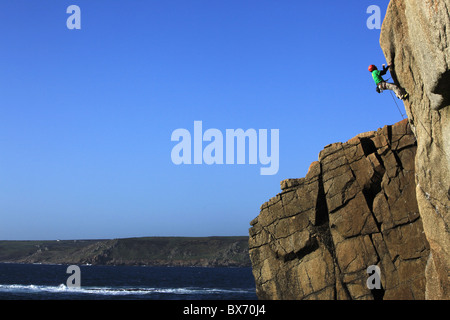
0, 0, 403, 240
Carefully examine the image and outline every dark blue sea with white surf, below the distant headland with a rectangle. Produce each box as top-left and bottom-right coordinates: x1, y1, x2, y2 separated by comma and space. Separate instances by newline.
0, 263, 257, 300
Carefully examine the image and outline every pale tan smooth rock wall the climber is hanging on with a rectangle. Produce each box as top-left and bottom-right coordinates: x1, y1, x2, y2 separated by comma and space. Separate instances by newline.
380, 0, 450, 299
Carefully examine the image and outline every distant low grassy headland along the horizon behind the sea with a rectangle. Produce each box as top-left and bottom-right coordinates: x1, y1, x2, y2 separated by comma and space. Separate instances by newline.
0, 236, 251, 267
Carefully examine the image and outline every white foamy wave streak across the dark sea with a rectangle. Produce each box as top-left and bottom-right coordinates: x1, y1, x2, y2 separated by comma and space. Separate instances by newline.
0, 284, 251, 296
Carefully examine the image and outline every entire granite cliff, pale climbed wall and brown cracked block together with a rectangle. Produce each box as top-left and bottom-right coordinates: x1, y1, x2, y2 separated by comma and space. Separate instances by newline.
249, 0, 450, 299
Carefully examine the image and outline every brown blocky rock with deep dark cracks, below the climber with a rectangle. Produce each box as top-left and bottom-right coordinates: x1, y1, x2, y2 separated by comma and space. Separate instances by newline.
249, 120, 429, 300
